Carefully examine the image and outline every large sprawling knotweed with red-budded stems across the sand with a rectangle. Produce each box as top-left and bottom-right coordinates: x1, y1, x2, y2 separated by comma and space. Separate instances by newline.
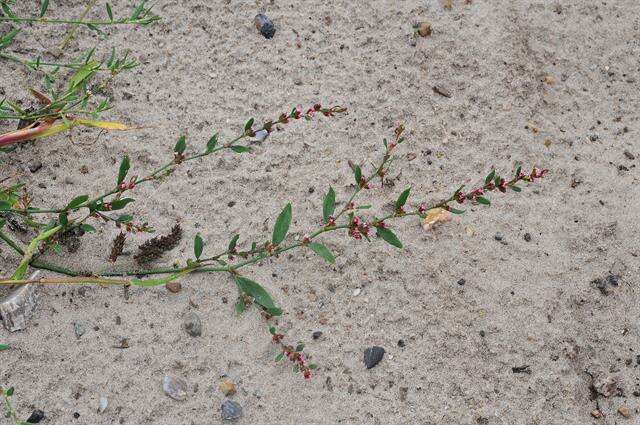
0, 104, 546, 378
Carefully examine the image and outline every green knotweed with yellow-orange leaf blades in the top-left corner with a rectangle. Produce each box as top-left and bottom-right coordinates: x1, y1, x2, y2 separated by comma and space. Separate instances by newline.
0, 0, 160, 149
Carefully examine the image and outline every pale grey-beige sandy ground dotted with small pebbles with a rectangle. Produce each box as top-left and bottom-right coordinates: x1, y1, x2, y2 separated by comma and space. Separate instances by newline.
0, 0, 640, 424
